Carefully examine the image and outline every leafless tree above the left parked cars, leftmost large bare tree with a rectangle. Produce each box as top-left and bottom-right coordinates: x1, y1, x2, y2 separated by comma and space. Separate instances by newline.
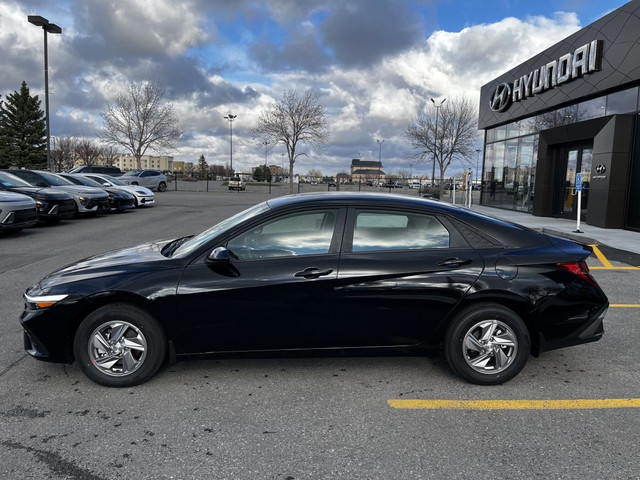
98, 82, 184, 168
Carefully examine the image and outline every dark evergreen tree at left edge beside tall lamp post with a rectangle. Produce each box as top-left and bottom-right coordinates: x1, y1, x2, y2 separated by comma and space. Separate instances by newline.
0, 81, 47, 168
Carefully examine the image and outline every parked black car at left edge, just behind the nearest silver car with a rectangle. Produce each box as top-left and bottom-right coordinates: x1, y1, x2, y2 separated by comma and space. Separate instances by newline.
0, 170, 76, 223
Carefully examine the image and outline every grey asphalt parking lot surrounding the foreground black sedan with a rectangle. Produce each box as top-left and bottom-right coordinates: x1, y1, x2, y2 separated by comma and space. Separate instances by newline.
0, 189, 640, 480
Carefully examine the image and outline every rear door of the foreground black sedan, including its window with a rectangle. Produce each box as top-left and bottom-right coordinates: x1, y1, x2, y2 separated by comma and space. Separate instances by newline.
335, 207, 484, 347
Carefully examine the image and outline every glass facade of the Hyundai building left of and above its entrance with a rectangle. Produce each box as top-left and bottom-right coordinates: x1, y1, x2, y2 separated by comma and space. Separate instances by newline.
481, 87, 640, 212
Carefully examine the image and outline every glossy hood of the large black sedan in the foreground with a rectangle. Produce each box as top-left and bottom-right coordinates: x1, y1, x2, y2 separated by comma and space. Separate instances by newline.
40, 240, 176, 291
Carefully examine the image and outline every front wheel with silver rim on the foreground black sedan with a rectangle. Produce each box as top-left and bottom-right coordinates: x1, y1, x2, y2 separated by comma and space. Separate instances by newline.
73, 303, 167, 387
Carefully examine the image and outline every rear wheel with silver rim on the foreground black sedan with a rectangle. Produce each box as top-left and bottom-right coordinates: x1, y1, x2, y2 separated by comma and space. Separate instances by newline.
443, 303, 531, 385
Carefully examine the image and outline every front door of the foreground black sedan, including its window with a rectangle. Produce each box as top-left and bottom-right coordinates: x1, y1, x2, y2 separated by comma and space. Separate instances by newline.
172, 207, 346, 352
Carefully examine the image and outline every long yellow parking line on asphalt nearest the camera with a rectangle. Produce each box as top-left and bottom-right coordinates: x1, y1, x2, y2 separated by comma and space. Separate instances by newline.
387, 398, 640, 410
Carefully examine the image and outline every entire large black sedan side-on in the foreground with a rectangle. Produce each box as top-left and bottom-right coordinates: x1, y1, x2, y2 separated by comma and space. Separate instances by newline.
20, 192, 608, 387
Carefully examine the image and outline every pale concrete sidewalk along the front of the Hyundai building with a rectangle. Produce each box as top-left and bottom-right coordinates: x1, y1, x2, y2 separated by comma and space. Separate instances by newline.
444, 197, 640, 255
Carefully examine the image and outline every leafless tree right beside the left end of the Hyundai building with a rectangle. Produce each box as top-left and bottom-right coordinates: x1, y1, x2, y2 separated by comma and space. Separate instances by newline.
405, 98, 478, 196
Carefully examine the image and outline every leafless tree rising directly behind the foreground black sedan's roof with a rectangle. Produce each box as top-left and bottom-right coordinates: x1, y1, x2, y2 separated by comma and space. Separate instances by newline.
253, 90, 329, 193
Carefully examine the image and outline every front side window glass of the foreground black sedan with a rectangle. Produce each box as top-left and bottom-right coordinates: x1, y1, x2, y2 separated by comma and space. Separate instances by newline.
227, 209, 338, 260
